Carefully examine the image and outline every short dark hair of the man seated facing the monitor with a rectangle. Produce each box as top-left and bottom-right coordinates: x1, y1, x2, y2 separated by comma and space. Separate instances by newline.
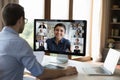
2, 3, 25, 26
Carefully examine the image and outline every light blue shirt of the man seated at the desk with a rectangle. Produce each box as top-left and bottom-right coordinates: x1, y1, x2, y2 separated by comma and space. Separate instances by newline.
0, 27, 44, 80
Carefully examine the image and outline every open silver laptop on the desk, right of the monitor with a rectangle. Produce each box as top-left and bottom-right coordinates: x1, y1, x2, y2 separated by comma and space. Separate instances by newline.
83, 48, 120, 76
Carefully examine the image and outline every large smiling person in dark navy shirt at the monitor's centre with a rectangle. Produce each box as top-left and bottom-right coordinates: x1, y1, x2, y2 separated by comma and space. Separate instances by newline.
46, 23, 71, 61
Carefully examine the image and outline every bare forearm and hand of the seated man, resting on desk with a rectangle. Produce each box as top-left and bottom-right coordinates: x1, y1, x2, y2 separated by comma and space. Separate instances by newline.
37, 67, 77, 80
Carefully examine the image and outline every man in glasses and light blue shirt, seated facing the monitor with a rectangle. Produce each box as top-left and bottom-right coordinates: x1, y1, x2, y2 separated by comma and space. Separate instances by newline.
0, 3, 77, 80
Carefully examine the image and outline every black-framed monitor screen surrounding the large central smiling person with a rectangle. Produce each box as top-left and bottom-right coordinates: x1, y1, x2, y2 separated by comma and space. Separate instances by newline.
34, 19, 87, 56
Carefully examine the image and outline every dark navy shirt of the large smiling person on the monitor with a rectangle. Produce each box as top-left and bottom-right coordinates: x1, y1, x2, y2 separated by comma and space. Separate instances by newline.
46, 37, 70, 52
